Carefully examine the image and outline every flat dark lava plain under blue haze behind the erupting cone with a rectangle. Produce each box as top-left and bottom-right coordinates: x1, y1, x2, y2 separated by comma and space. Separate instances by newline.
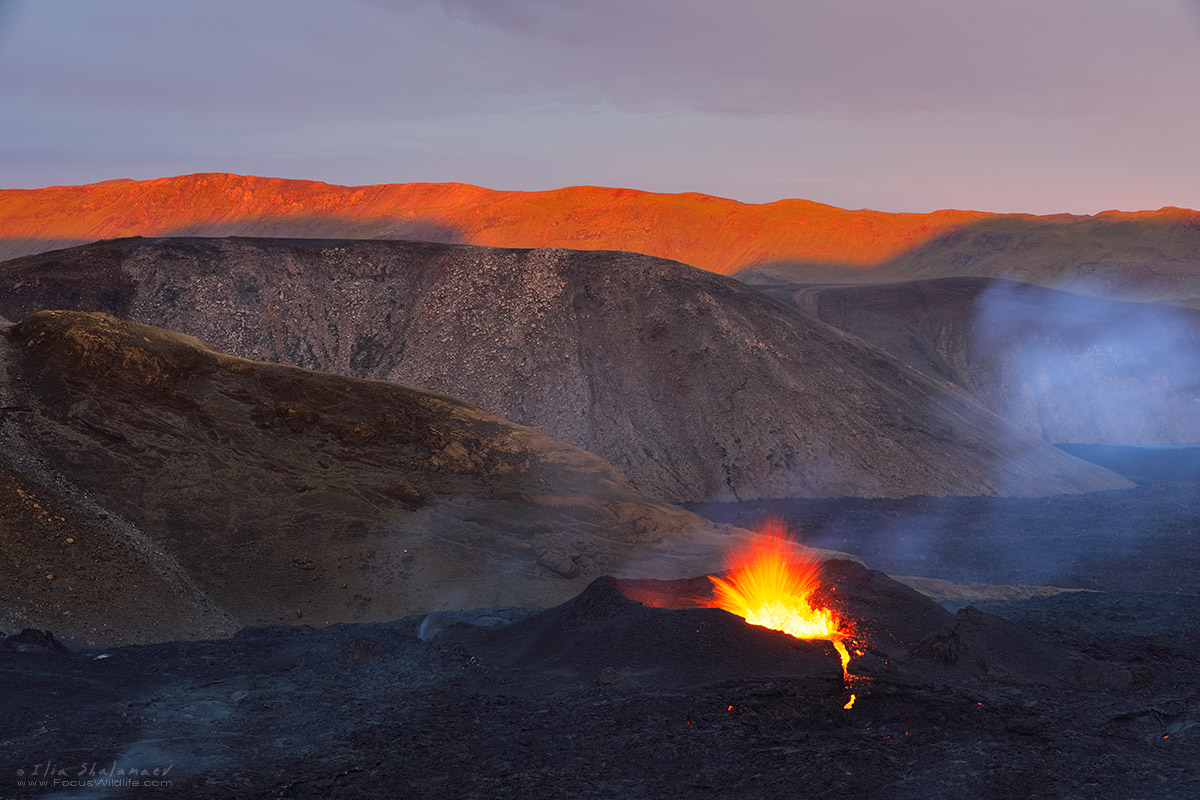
703, 489, 1200, 596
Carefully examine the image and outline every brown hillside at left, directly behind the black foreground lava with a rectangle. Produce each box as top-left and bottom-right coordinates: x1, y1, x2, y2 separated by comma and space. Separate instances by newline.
0, 312, 726, 643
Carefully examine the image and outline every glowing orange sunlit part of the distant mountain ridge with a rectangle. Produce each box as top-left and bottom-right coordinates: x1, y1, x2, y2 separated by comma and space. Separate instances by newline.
0, 174, 989, 268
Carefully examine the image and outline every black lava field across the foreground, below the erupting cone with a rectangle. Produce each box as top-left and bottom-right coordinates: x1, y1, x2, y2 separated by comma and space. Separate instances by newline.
0, 582, 1200, 800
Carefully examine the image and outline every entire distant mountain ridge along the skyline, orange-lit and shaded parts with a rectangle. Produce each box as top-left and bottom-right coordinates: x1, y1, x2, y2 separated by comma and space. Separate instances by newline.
0, 174, 1200, 303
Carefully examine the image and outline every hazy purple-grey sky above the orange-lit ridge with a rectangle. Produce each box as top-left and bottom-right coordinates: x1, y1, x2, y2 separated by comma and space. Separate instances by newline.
0, 0, 1200, 213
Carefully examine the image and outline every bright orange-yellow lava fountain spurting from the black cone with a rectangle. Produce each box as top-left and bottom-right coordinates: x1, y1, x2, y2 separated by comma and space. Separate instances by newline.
708, 522, 853, 681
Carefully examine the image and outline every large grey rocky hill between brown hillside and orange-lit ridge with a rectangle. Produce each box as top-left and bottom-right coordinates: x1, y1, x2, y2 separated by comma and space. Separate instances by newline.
0, 239, 1129, 500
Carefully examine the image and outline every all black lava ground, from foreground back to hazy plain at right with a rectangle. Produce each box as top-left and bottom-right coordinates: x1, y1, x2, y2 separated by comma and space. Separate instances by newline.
0, 450, 1200, 800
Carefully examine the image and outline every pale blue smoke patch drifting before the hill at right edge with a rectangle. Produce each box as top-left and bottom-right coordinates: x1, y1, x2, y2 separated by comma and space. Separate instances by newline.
967, 281, 1200, 445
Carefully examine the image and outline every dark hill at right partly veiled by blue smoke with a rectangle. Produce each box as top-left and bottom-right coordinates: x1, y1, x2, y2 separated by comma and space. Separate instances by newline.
766, 278, 1200, 445
